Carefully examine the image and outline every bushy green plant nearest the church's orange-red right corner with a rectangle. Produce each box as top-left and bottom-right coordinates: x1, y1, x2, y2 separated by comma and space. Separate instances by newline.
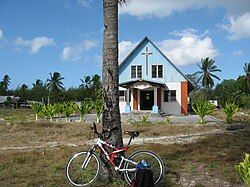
192, 101, 214, 124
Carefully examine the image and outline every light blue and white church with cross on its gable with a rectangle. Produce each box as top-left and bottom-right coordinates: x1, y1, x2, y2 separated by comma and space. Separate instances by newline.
119, 37, 193, 115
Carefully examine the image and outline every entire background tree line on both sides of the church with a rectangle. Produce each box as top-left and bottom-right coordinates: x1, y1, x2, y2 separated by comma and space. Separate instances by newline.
0, 58, 250, 108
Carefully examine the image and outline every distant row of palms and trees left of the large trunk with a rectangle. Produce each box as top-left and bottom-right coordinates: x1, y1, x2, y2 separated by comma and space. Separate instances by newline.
0, 72, 102, 103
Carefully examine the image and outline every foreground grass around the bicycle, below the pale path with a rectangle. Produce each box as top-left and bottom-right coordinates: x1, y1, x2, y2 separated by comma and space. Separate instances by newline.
0, 132, 250, 186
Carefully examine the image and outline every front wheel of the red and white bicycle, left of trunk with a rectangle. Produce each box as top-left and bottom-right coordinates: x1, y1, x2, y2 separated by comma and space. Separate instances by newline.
66, 151, 100, 186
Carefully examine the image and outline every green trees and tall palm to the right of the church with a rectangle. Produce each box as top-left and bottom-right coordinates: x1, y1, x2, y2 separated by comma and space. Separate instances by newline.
187, 58, 250, 108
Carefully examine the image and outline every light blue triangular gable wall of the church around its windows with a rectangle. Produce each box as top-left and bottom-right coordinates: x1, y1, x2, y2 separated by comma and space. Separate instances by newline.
119, 37, 188, 83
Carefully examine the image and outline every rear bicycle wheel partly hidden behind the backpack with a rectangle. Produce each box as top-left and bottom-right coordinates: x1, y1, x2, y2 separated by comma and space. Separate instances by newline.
124, 151, 164, 184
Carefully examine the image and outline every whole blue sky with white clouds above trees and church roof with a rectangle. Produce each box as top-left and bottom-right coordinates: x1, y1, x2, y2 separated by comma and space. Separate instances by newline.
0, 0, 250, 89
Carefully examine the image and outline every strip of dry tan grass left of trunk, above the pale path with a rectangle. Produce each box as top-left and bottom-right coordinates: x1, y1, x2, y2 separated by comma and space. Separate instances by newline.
0, 122, 94, 147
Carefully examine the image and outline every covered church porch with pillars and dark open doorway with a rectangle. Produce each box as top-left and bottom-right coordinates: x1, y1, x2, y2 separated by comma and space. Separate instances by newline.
119, 80, 166, 113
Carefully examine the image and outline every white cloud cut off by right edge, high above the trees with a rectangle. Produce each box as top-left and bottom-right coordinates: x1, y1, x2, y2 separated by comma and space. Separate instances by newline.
221, 12, 250, 40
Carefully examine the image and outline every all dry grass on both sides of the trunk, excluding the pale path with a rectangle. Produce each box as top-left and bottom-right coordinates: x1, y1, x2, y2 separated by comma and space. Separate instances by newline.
0, 110, 250, 187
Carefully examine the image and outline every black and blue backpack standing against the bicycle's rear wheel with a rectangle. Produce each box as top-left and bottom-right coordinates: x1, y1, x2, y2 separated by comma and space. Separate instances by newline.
132, 160, 154, 187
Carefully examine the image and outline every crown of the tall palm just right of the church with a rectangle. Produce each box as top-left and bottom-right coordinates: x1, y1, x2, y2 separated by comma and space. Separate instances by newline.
195, 57, 221, 91
